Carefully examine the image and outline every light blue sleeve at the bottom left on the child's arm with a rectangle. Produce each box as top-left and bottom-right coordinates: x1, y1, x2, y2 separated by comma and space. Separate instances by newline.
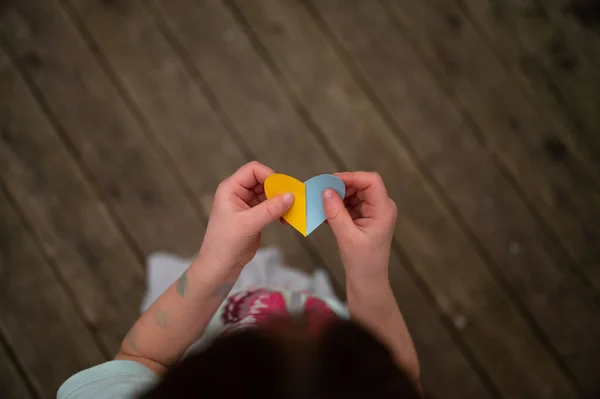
56, 360, 158, 399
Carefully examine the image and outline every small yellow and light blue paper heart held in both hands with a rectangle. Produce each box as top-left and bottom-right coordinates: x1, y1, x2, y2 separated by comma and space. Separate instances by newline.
265, 173, 346, 237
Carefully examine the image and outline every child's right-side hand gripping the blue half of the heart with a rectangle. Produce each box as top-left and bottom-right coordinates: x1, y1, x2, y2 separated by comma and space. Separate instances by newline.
323, 172, 397, 281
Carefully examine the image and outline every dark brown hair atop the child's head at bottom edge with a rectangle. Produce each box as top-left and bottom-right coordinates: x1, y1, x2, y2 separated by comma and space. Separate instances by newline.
141, 320, 420, 399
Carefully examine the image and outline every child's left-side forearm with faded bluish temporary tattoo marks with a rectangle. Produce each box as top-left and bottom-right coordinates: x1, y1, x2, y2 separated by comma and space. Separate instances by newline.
115, 258, 236, 374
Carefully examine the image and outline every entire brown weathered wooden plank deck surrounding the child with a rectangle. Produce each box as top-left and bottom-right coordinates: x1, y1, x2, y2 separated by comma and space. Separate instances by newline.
0, 0, 600, 399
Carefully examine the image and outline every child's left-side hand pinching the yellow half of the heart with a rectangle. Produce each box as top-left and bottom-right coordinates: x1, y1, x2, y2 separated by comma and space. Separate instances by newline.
198, 161, 294, 278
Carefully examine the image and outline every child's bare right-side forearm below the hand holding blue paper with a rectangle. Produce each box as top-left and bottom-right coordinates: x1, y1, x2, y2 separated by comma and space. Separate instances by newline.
346, 275, 420, 385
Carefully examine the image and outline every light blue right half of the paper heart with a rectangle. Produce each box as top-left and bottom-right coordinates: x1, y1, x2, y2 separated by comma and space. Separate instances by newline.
304, 175, 346, 235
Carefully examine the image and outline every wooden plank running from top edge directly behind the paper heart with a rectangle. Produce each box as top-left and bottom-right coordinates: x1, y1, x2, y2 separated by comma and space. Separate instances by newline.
150, 1, 496, 397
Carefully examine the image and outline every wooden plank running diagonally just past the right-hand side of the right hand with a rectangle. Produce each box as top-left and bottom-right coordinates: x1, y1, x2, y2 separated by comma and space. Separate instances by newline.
227, 0, 588, 396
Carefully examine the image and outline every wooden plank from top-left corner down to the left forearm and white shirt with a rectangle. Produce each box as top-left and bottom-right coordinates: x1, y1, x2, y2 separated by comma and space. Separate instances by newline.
2, 0, 204, 255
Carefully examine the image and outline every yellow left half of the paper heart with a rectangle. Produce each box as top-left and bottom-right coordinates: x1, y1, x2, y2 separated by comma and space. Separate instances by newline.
265, 173, 306, 237
